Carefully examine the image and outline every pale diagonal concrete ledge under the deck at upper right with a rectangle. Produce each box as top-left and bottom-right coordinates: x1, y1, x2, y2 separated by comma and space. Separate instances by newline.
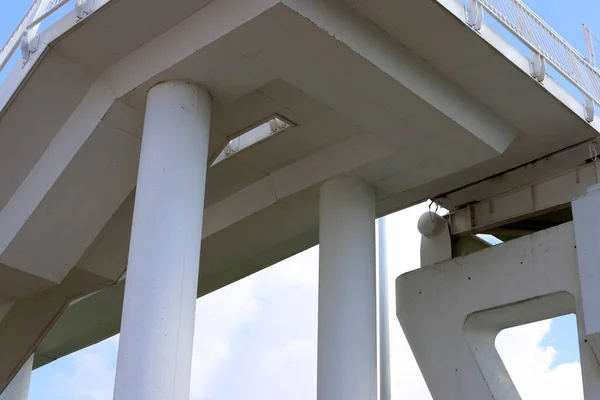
282, 0, 520, 154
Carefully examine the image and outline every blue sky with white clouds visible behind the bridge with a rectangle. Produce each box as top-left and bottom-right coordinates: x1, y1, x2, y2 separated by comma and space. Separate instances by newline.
0, 0, 600, 400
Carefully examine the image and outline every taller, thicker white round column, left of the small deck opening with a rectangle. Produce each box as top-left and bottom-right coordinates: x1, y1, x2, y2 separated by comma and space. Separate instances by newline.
114, 81, 211, 400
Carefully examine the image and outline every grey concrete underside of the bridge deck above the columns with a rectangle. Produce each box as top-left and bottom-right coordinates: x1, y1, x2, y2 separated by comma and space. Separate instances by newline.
0, 0, 597, 396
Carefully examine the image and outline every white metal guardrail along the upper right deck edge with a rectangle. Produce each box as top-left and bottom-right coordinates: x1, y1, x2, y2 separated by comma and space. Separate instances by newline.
466, 0, 600, 121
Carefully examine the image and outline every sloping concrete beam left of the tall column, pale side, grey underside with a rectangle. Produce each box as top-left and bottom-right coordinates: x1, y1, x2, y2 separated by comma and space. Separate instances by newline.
0, 84, 135, 283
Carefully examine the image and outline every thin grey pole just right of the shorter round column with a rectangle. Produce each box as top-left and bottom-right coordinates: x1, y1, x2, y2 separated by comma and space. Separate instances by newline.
377, 217, 392, 400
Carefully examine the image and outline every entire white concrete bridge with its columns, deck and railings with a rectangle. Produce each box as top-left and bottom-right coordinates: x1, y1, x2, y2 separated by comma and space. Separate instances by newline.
0, 0, 600, 400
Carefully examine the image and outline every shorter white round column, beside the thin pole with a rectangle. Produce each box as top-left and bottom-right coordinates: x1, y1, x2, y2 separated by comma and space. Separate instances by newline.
317, 178, 377, 400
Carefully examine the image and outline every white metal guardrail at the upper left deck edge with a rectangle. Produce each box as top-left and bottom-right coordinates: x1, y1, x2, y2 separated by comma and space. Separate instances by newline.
0, 0, 94, 73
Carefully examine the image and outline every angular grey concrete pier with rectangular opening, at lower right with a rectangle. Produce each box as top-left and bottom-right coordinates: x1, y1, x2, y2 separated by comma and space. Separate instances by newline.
396, 185, 600, 400
